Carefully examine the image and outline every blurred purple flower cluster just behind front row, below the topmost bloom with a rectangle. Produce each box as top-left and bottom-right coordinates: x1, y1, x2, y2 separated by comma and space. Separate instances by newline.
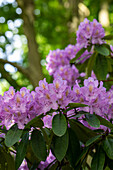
46, 44, 92, 86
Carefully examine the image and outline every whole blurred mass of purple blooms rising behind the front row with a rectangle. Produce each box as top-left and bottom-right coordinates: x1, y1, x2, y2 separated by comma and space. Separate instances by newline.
46, 18, 105, 86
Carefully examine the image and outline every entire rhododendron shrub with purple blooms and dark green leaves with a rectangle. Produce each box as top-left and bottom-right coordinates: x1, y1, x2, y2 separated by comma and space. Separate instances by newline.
0, 19, 113, 170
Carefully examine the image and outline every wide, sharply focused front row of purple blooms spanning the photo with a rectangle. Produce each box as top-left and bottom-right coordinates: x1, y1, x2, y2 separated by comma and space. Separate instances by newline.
0, 77, 113, 129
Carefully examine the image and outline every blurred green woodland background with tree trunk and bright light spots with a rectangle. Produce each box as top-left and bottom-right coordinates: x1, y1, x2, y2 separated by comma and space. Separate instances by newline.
0, 0, 113, 94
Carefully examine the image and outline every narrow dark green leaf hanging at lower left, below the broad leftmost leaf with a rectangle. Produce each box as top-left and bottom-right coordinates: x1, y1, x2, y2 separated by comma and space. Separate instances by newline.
15, 133, 29, 169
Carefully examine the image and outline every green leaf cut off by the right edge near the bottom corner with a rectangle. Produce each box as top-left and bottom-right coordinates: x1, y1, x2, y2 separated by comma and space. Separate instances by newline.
103, 138, 113, 159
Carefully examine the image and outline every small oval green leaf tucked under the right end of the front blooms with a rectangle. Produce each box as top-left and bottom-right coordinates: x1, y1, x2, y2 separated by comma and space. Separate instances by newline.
86, 114, 100, 128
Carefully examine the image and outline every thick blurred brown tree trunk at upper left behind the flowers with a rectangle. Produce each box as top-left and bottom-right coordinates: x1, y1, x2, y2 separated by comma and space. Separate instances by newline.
17, 0, 43, 87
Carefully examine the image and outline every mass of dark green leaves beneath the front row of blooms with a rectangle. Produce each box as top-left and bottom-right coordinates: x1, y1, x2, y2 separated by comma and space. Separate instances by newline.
0, 103, 113, 170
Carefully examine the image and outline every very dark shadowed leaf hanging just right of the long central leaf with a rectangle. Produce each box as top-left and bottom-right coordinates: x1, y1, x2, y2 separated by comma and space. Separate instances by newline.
66, 128, 80, 168
